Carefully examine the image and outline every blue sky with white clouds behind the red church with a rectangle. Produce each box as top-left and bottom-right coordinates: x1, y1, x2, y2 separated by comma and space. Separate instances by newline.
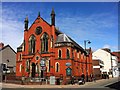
0, 2, 118, 51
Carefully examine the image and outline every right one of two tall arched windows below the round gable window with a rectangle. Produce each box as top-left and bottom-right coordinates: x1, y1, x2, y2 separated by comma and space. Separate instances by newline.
41, 33, 48, 52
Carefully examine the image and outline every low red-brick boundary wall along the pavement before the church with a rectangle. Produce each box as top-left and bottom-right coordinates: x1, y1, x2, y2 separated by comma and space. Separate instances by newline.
3, 74, 100, 85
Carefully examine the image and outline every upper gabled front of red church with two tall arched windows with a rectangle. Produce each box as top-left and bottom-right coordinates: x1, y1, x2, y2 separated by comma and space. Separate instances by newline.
20, 9, 56, 55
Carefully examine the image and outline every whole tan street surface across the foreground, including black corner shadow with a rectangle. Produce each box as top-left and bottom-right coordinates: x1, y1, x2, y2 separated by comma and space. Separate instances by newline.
0, 77, 120, 90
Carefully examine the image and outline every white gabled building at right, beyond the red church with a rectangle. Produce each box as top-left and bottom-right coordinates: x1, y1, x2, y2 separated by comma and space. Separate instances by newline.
92, 48, 119, 77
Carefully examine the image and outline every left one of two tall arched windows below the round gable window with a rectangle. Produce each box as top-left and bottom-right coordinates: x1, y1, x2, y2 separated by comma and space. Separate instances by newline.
29, 35, 36, 54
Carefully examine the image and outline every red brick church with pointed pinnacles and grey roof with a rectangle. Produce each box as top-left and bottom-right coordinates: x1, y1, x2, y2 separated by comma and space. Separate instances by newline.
16, 9, 93, 80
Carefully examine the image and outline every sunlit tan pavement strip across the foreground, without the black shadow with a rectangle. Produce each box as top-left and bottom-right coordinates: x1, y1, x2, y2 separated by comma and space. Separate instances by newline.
0, 77, 120, 88
